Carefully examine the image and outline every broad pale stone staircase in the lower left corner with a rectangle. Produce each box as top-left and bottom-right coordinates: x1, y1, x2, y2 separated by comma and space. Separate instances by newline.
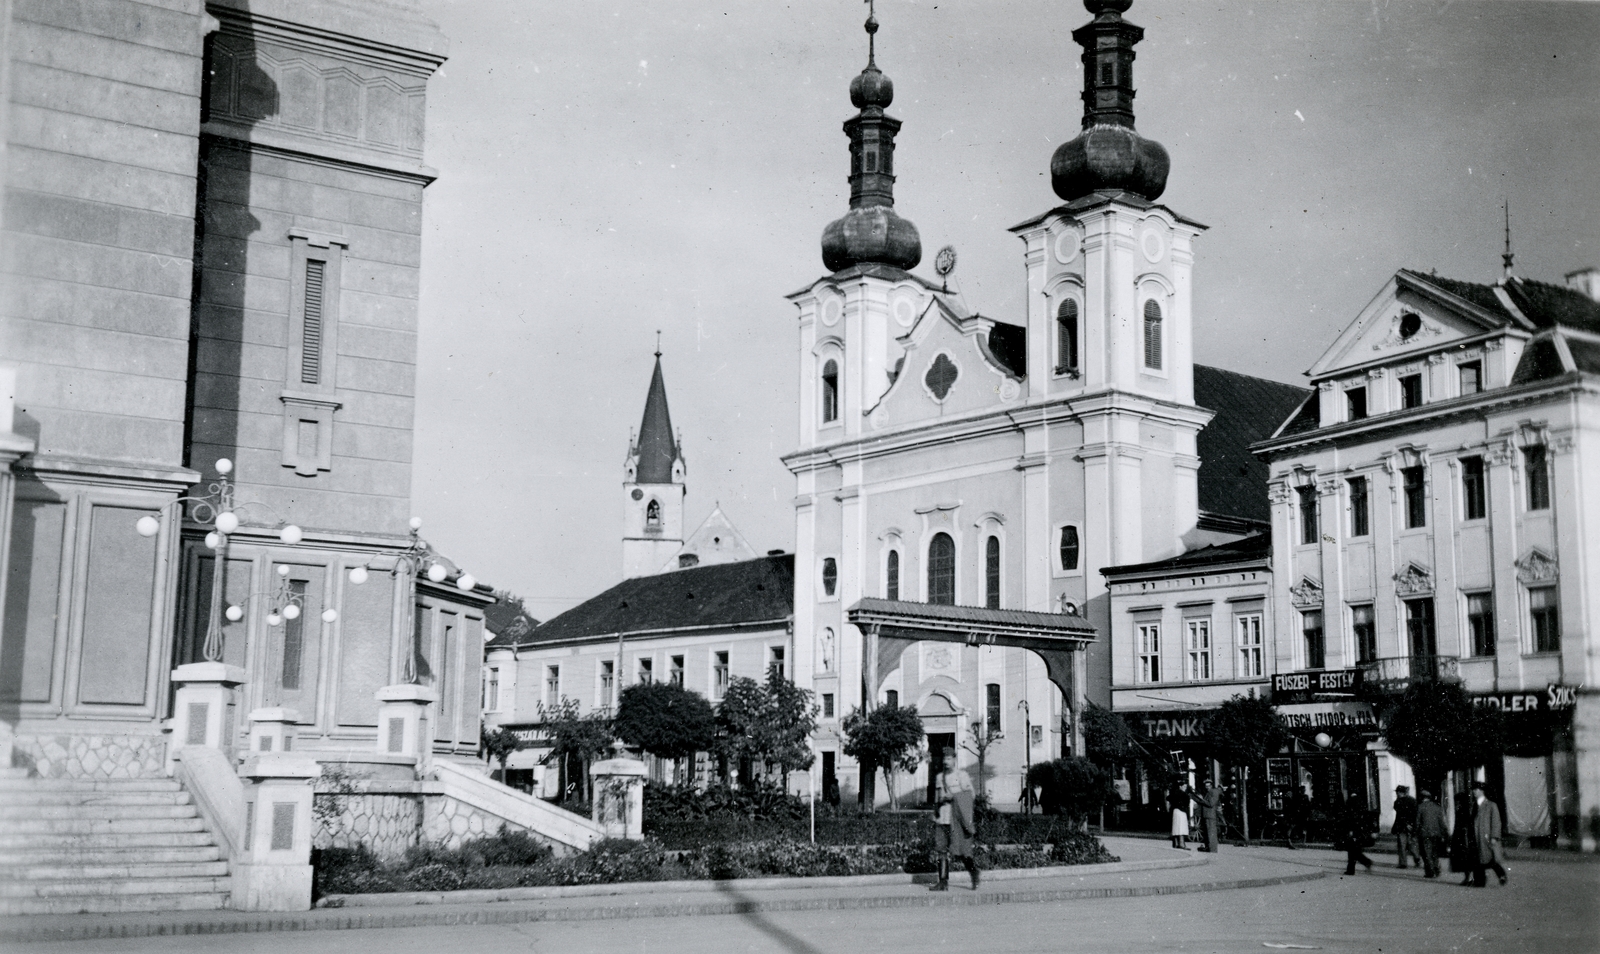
0, 768, 230, 916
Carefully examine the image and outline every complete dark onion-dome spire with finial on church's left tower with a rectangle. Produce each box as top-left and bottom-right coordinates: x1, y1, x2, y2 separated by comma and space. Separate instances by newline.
822, 14, 922, 272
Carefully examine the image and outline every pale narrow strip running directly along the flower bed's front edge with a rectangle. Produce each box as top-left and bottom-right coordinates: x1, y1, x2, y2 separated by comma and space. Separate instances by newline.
317, 858, 1206, 911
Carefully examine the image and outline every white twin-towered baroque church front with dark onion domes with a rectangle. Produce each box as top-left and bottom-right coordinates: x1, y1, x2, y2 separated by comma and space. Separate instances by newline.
784, 3, 1264, 807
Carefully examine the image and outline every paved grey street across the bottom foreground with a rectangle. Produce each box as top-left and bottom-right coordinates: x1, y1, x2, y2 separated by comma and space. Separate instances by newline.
28, 848, 1600, 954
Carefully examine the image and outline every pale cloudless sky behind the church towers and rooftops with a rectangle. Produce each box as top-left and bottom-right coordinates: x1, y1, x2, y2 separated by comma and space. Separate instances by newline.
413, 0, 1600, 618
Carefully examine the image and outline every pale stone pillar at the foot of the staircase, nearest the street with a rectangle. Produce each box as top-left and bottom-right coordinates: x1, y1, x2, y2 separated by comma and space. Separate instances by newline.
232, 754, 322, 911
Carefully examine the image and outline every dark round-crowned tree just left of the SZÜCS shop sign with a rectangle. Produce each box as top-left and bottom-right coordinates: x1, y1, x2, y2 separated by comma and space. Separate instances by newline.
1382, 682, 1504, 791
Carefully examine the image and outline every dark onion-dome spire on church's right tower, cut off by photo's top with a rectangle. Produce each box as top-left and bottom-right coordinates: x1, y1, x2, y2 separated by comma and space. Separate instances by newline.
1050, 0, 1171, 202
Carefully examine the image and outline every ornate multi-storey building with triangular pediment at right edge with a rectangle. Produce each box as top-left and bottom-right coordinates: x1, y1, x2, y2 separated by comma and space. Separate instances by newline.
1259, 264, 1600, 850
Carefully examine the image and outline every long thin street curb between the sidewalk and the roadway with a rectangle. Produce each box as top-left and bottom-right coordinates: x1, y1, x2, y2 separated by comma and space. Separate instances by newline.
0, 871, 1326, 943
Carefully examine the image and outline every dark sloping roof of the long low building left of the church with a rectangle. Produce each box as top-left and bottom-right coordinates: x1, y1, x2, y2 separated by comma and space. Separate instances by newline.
490, 554, 795, 648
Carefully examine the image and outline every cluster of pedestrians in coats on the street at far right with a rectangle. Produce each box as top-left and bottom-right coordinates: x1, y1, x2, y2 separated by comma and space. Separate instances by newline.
1388, 781, 1507, 888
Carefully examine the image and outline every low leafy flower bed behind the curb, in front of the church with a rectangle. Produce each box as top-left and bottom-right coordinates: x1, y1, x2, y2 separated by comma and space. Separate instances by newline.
315, 829, 1117, 896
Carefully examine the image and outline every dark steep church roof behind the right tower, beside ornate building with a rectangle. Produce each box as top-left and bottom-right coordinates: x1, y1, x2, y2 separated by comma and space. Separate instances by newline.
1195, 365, 1310, 522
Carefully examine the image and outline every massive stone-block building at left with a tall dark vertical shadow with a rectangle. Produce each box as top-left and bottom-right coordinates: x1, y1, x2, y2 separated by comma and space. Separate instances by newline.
0, 0, 590, 912
